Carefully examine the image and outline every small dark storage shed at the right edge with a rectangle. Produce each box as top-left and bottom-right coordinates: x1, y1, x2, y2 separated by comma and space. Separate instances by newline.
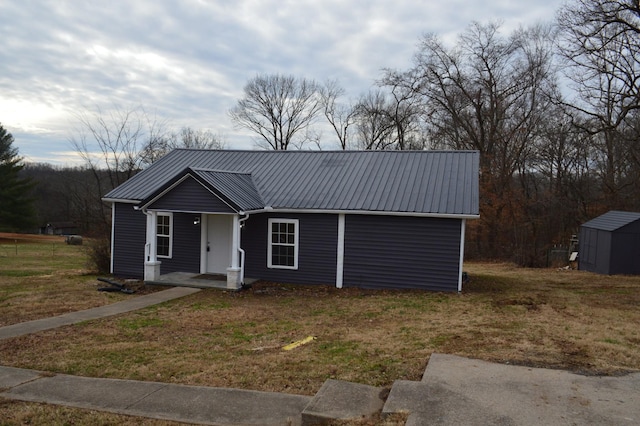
578, 210, 640, 275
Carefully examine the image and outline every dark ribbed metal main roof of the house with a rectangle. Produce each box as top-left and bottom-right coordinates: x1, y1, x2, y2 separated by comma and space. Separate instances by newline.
105, 149, 479, 216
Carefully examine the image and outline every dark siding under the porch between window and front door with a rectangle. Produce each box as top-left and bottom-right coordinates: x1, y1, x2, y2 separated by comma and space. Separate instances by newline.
158, 213, 200, 274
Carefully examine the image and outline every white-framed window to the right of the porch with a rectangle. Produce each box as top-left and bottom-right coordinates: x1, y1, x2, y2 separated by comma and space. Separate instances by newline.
267, 219, 298, 269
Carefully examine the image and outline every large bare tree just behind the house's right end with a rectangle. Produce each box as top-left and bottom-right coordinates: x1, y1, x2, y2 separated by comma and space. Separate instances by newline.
383, 23, 555, 256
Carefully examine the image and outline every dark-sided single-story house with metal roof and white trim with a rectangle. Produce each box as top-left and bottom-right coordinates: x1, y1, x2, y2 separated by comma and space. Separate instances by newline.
103, 149, 479, 291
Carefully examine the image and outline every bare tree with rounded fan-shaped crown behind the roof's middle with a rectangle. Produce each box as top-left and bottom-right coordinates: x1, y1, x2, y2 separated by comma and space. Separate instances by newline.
229, 74, 322, 150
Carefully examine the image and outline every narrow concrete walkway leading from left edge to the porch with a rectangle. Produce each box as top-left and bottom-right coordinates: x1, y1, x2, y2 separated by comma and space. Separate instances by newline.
0, 287, 200, 340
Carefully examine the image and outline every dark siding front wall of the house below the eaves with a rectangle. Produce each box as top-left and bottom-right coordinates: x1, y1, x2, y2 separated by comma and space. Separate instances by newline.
113, 203, 462, 291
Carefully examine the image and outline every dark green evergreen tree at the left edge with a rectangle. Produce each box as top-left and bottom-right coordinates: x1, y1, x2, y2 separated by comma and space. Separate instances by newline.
0, 123, 35, 232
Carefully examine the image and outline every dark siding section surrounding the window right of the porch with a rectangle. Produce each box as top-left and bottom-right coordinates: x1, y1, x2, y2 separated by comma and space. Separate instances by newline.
242, 213, 338, 285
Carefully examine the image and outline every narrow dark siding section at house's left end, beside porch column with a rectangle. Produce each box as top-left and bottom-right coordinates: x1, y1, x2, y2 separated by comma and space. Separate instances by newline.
112, 203, 147, 279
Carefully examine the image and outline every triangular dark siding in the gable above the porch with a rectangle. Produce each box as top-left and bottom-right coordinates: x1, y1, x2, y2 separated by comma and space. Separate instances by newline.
148, 177, 235, 213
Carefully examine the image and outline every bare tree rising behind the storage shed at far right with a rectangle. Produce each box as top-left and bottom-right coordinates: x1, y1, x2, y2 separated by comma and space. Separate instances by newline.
557, 0, 640, 208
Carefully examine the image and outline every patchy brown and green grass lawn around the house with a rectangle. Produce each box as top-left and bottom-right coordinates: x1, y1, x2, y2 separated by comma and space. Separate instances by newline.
0, 236, 640, 424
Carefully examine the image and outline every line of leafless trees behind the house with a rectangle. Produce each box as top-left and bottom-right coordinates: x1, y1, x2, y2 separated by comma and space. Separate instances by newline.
5, 0, 640, 266
